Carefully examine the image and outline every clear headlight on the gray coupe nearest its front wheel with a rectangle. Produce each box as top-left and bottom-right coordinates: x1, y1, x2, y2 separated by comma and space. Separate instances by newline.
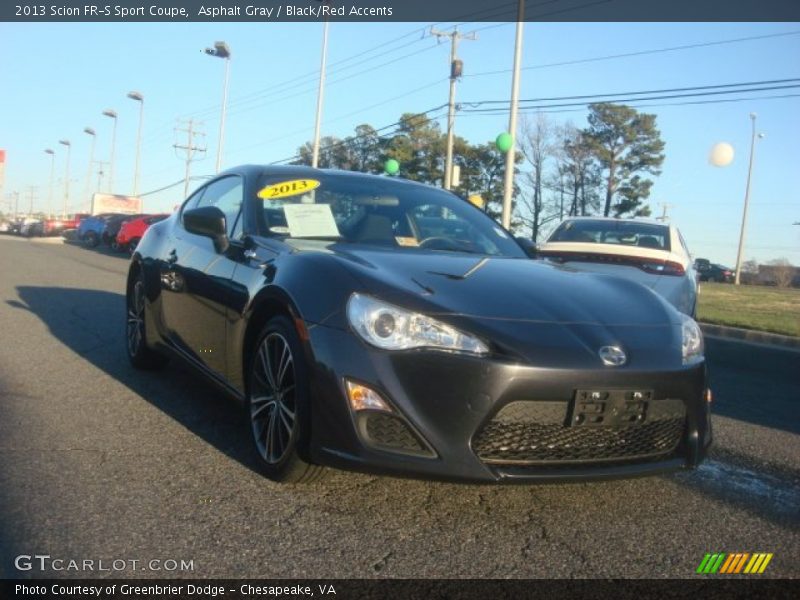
347, 293, 489, 355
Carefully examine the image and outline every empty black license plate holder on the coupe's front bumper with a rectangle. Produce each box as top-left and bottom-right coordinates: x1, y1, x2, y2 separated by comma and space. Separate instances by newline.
567, 389, 653, 427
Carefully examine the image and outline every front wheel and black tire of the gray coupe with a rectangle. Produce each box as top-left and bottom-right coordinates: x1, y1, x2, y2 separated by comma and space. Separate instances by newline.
245, 316, 326, 483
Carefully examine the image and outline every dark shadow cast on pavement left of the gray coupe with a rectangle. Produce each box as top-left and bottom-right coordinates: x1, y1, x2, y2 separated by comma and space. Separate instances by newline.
8, 286, 258, 478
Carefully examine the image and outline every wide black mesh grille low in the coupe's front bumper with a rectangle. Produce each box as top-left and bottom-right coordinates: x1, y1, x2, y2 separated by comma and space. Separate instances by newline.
473, 408, 685, 464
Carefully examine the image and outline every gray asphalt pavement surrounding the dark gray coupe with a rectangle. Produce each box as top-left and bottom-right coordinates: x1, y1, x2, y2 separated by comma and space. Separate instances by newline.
0, 236, 800, 578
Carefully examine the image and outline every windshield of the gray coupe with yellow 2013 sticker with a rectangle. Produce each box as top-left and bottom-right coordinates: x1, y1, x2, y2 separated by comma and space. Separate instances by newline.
258, 175, 525, 258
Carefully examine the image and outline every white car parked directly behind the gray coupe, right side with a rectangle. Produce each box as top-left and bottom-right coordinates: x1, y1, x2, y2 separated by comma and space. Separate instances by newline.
538, 217, 697, 316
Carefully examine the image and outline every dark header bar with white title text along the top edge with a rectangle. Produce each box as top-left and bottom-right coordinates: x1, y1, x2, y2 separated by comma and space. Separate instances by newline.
0, 0, 800, 23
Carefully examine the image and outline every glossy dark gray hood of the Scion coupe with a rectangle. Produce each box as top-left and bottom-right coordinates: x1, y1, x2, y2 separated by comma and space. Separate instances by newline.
318, 244, 680, 369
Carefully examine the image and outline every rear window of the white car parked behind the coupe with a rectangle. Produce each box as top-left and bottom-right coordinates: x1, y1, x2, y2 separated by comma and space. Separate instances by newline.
547, 219, 670, 251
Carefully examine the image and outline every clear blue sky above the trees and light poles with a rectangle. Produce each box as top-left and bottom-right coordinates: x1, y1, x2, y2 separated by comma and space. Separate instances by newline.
0, 23, 800, 266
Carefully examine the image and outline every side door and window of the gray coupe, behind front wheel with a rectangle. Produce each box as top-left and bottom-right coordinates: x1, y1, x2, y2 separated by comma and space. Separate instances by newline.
162, 175, 244, 378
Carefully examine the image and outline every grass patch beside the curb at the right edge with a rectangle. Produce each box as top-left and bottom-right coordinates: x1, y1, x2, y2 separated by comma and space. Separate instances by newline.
697, 282, 800, 337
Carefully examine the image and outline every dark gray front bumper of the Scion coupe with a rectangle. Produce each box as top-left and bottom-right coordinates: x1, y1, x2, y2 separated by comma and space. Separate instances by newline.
308, 325, 711, 482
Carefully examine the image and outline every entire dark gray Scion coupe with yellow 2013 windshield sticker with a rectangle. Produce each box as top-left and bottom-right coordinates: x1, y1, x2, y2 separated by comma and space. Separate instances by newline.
127, 166, 711, 482
